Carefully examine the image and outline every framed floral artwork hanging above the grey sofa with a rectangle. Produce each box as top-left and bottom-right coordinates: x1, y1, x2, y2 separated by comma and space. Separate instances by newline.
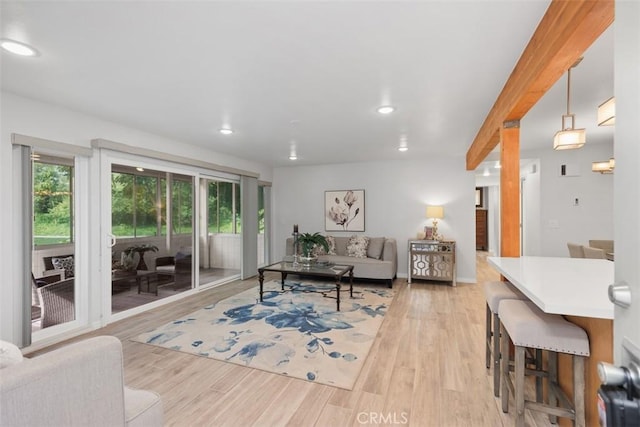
324, 190, 364, 231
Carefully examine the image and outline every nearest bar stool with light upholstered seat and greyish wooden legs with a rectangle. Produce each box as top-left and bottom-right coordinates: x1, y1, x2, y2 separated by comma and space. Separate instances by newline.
499, 300, 589, 426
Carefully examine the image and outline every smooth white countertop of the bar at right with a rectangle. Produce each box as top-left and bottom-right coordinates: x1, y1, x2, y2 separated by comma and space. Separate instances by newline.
487, 256, 614, 319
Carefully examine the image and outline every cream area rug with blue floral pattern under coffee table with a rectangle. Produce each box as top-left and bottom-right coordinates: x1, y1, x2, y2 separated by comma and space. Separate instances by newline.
134, 280, 393, 390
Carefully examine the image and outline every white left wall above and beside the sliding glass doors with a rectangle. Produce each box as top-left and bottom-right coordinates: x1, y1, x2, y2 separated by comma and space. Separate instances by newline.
0, 92, 272, 342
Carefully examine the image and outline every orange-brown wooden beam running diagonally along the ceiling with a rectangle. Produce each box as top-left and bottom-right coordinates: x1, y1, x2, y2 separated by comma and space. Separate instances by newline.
467, 0, 614, 170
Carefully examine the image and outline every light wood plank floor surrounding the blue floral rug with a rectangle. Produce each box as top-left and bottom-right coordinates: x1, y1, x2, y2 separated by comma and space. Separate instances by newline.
30, 252, 550, 427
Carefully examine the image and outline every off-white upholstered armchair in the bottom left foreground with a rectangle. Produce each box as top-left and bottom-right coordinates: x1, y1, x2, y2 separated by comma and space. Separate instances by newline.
0, 336, 163, 427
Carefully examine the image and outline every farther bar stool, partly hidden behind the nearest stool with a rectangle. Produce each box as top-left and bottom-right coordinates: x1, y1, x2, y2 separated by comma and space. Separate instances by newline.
484, 281, 527, 397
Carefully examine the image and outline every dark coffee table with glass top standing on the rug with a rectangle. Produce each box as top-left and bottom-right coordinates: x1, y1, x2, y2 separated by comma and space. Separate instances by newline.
258, 262, 353, 311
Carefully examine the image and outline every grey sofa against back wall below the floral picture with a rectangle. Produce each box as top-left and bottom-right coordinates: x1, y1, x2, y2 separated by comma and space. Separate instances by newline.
286, 236, 398, 287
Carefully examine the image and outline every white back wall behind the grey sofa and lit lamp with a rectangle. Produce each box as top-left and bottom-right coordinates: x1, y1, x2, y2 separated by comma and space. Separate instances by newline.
272, 157, 476, 282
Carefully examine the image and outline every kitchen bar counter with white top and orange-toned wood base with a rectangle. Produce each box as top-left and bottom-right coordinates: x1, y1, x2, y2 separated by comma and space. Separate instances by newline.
487, 257, 614, 426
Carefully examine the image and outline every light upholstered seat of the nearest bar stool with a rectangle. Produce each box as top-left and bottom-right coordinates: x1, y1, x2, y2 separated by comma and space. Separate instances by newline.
498, 300, 589, 356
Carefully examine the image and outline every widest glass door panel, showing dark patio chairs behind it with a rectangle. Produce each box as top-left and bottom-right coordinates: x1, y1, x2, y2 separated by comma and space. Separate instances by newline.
111, 163, 194, 313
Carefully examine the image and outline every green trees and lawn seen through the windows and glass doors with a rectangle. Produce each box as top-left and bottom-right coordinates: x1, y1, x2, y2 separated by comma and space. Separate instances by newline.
33, 161, 264, 246
